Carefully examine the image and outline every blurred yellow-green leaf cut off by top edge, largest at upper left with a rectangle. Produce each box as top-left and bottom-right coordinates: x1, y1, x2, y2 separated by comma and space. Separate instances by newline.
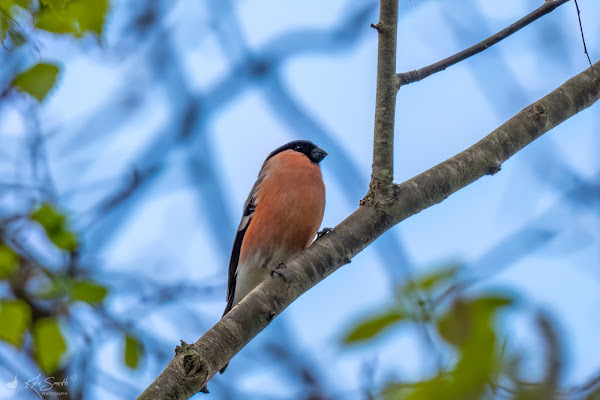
35, 0, 108, 37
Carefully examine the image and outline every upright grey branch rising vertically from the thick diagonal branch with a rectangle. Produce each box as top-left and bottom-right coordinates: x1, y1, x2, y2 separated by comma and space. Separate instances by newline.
371, 0, 398, 195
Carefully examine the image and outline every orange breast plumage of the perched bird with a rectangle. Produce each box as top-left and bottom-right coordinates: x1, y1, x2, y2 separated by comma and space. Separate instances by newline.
240, 150, 325, 263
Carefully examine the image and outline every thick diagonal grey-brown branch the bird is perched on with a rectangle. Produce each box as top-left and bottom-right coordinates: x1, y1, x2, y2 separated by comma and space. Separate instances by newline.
138, 62, 600, 400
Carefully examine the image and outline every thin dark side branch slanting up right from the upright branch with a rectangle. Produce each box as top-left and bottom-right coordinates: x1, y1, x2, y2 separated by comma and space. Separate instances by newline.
398, 0, 569, 88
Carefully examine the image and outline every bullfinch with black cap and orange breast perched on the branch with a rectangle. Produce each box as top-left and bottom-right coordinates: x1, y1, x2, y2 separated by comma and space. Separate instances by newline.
221, 140, 327, 373
